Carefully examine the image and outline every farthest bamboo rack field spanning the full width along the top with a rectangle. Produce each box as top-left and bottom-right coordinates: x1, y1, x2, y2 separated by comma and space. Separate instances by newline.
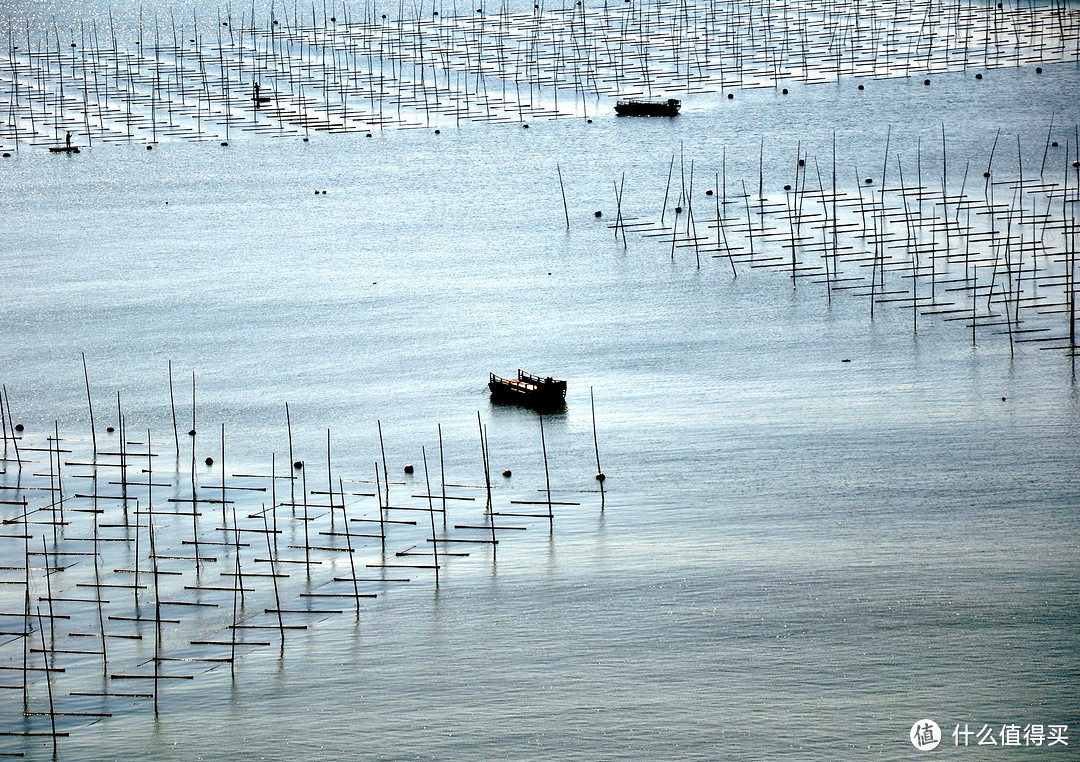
0, 0, 1080, 150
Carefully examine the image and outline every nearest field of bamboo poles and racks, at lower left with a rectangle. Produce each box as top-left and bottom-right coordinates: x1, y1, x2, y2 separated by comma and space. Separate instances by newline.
0, 371, 603, 754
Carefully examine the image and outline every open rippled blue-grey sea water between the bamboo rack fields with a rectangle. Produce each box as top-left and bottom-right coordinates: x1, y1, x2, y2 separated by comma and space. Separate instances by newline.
0, 4, 1080, 760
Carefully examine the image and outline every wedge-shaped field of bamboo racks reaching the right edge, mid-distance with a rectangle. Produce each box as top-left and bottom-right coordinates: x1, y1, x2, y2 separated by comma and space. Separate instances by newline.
597, 130, 1080, 356
